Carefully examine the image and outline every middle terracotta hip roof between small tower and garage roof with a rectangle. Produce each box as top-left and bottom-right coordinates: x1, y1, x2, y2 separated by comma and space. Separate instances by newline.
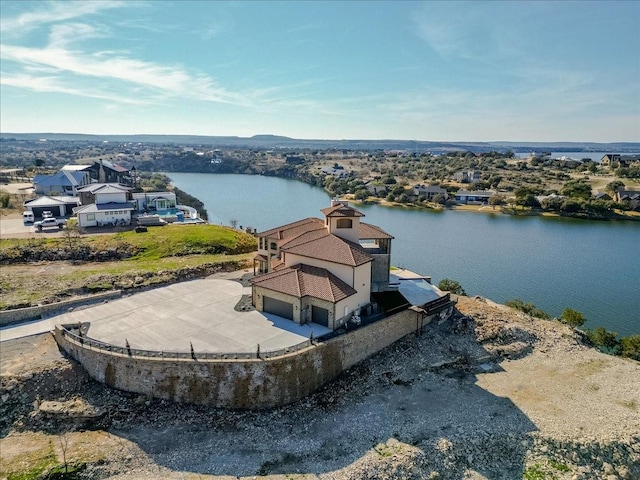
282, 234, 373, 267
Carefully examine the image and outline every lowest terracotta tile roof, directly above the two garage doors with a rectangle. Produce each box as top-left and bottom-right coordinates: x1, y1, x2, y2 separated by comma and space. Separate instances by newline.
251, 264, 357, 303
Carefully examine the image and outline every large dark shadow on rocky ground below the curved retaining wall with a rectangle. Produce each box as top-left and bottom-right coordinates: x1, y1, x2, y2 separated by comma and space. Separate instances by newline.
108, 317, 537, 480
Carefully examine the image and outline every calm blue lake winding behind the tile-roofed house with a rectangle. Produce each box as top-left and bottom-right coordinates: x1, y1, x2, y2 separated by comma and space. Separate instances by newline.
167, 173, 640, 335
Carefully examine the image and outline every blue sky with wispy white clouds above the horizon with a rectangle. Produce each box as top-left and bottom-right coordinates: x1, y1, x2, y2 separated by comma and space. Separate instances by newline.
0, 0, 640, 142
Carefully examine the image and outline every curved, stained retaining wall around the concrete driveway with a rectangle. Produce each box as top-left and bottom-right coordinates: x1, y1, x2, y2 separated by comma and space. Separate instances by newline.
54, 311, 424, 409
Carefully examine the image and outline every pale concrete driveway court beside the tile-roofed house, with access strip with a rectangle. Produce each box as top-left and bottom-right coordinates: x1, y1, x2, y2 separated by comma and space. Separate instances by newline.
0, 278, 329, 353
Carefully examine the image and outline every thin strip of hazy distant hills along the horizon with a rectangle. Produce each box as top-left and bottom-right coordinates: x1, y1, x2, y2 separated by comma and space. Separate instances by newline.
0, 133, 640, 153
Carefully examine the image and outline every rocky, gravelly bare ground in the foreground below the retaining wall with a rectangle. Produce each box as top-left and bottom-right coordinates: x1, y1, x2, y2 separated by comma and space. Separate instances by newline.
0, 297, 640, 480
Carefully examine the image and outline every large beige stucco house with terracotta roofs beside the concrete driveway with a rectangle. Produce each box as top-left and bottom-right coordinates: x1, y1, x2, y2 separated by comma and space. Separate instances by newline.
252, 200, 393, 329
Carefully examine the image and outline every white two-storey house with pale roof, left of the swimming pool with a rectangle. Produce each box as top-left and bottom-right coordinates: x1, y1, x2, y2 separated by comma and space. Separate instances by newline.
73, 183, 135, 227
